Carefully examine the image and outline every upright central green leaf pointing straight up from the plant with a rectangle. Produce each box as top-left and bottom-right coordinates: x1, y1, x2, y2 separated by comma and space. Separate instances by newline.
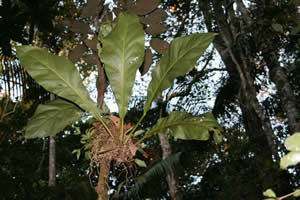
100, 13, 145, 118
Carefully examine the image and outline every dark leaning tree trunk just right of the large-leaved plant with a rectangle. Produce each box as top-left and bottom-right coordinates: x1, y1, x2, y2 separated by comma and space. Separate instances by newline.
201, 0, 289, 195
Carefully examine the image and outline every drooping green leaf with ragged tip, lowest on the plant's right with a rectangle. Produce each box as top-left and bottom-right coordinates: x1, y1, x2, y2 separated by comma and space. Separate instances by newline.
146, 111, 222, 140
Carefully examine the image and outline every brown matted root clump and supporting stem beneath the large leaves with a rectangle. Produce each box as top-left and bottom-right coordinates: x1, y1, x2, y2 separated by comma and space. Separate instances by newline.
90, 116, 138, 200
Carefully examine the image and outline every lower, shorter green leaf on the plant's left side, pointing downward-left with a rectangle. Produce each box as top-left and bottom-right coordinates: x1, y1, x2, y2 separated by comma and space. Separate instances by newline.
25, 99, 82, 138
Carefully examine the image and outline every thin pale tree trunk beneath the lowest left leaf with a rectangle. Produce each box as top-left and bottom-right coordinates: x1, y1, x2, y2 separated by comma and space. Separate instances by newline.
48, 136, 56, 187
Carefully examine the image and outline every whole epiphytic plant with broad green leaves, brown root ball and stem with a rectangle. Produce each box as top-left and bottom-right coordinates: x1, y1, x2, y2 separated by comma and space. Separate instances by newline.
17, 12, 222, 199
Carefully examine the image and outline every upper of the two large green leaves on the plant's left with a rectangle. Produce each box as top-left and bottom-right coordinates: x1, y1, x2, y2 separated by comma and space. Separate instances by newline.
17, 46, 101, 121
